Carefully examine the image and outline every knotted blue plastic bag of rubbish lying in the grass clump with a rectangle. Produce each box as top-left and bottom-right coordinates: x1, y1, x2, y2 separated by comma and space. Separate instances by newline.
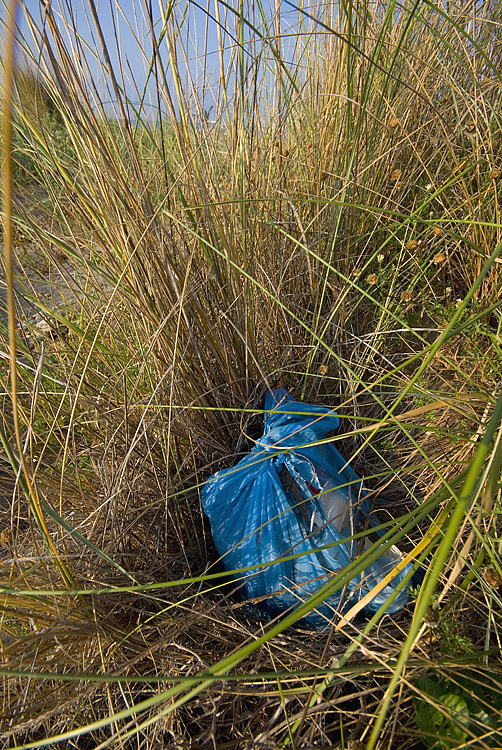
201, 388, 410, 628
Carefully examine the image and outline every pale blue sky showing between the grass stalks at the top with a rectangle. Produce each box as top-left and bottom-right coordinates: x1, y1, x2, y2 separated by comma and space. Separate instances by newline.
7, 0, 306, 119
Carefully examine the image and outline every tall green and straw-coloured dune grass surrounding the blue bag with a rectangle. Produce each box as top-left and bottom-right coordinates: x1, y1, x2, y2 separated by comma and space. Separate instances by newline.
0, 0, 502, 749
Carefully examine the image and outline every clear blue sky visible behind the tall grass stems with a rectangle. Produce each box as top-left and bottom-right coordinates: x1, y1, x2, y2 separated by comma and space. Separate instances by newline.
9, 0, 306, 119
